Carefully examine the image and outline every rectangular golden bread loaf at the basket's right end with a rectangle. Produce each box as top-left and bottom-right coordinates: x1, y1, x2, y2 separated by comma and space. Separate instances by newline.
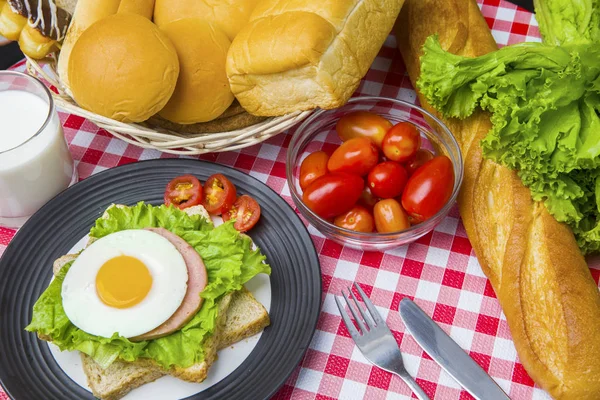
227, 0, 404, 116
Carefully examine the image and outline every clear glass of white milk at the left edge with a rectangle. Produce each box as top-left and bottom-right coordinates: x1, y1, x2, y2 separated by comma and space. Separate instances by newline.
0, 71, 77, 228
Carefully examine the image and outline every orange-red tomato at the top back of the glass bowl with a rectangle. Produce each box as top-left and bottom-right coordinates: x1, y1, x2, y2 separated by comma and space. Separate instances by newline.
335, 111, 392, 148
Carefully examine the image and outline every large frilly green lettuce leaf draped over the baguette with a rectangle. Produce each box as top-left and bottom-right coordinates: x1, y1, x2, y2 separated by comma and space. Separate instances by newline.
417, 36, 600, 254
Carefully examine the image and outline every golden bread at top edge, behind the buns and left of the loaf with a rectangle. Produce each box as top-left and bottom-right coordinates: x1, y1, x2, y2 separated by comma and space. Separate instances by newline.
154, 0, 260, 40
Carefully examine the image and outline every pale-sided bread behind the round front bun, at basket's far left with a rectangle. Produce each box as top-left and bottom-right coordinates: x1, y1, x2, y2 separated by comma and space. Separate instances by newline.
56, 0, 121, 88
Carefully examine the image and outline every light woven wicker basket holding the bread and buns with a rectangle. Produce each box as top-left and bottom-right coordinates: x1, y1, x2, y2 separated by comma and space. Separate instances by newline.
27, 55, 312, 155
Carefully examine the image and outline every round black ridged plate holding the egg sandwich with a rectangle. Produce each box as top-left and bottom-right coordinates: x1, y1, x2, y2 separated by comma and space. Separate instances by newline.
0, 159, 321, 400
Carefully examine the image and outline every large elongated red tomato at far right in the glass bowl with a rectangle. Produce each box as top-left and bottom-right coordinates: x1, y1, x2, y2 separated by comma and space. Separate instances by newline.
402, 156, 454, 222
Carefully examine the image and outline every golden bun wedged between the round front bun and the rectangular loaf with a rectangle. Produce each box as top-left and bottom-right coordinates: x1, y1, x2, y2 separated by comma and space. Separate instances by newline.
159, 18, 234, 125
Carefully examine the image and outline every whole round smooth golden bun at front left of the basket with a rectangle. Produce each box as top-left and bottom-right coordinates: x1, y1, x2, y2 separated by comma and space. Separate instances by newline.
69, 13, 179, 122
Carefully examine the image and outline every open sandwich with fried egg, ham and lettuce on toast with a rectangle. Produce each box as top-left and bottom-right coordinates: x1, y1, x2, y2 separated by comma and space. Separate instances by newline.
26, 203, 270, 400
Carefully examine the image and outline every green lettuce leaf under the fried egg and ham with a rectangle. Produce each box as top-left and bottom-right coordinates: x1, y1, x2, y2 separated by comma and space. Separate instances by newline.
25, 203, 271, 368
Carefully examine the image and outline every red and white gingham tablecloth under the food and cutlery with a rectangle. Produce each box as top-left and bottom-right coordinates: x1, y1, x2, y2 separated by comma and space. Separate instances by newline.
0, 0, 600, 400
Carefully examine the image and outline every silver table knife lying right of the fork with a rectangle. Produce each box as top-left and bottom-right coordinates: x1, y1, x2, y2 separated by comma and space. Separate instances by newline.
399, 297, 510, 400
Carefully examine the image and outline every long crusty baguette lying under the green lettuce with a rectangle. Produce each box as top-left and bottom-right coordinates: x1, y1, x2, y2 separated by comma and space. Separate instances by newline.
395, 0, 600, 400
